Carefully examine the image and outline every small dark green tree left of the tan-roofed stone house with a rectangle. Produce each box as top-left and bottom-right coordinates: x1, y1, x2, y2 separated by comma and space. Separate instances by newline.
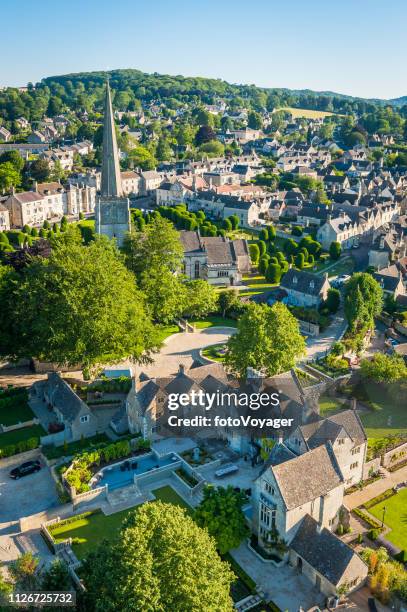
194, 485, 249, 554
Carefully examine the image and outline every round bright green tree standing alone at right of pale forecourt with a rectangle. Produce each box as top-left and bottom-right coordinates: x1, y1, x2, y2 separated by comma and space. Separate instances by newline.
225, 303, 305, 379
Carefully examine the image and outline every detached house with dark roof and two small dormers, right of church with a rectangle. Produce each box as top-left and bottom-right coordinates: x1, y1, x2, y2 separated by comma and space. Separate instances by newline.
280, 268, 331, 308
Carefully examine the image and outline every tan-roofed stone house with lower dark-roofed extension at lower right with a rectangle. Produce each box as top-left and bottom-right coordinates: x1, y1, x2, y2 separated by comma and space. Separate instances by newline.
252, 441, 368, 596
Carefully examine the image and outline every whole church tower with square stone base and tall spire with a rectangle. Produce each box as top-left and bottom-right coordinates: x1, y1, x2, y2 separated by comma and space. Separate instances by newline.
95, 82, 130, 247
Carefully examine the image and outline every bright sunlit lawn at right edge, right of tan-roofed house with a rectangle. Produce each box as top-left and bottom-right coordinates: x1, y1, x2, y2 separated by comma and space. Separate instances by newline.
369, 489, 407, 550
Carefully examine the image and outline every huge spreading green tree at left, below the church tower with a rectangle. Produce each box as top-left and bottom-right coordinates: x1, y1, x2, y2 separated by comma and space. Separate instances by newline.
0, 233, 159, 366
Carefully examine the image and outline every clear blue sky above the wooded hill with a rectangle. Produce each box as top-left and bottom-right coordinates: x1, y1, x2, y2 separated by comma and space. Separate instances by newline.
0, 0, 407, 98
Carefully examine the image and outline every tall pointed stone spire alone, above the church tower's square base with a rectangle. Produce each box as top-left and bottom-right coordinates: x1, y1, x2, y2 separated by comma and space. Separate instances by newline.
101, 81, 122, 197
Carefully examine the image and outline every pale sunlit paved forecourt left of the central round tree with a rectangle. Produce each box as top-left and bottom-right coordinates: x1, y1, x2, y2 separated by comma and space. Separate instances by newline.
141, 327, 236, 376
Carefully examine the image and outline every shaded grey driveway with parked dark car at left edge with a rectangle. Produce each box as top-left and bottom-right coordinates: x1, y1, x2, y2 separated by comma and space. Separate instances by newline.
0, 454, 59, 524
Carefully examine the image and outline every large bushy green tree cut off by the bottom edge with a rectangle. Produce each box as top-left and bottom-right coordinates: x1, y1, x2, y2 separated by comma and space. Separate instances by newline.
81, 502, 234, 612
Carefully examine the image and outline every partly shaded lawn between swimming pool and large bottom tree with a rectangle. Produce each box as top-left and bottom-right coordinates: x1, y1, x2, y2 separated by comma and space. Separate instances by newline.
52, 487, 191, 559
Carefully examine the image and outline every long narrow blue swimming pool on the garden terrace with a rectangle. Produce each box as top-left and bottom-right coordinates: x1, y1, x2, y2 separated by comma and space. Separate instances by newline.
92, 452, 179, 490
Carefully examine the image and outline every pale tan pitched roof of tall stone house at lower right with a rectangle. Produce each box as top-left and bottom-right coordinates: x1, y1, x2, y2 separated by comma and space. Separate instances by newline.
271, 444, 343, 510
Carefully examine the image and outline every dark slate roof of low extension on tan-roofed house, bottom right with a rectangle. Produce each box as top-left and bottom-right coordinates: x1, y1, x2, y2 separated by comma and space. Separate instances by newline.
290, 514, 367, 586
